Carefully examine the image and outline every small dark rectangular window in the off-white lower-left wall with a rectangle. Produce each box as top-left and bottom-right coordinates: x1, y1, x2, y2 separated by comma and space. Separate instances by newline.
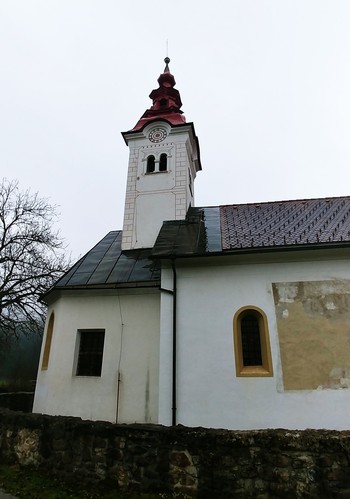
77, 329, 105, 376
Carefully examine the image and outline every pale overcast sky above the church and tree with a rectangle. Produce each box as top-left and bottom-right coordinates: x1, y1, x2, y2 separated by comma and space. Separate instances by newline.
0, 0, 350, 258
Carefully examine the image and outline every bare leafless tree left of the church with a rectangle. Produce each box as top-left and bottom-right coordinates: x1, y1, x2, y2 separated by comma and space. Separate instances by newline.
0, 179, 68, 344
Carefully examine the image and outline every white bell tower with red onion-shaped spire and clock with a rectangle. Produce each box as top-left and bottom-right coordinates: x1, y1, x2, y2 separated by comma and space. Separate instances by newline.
122, 57, 202, 250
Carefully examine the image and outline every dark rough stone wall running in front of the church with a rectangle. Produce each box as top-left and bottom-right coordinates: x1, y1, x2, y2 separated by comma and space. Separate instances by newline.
0, 410, 350, 499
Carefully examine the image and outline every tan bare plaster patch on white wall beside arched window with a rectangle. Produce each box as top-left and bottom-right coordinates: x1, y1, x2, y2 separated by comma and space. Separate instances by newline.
272, 280, 350, 390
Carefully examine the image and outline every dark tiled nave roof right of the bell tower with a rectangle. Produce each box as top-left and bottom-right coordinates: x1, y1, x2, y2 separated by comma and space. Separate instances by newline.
152, 197, 350, 258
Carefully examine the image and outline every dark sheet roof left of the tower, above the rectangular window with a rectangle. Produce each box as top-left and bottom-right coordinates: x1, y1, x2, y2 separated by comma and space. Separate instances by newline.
50, 230, 160, 291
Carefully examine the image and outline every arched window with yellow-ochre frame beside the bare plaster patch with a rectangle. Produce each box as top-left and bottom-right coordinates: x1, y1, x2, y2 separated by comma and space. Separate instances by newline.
233, 306, 273, 376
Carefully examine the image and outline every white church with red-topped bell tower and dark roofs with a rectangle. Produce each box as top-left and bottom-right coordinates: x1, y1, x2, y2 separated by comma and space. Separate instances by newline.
33, 58, 350, 430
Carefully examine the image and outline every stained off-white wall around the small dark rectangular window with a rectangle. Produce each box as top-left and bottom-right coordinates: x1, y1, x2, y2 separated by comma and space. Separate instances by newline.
33, 291, 159, 423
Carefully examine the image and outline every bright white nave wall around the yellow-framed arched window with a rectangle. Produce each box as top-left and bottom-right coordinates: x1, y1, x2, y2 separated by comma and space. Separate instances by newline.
159, 254, 350, 430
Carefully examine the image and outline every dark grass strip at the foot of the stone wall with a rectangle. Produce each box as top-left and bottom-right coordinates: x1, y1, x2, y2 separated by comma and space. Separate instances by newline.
0, 465, 187, 499
